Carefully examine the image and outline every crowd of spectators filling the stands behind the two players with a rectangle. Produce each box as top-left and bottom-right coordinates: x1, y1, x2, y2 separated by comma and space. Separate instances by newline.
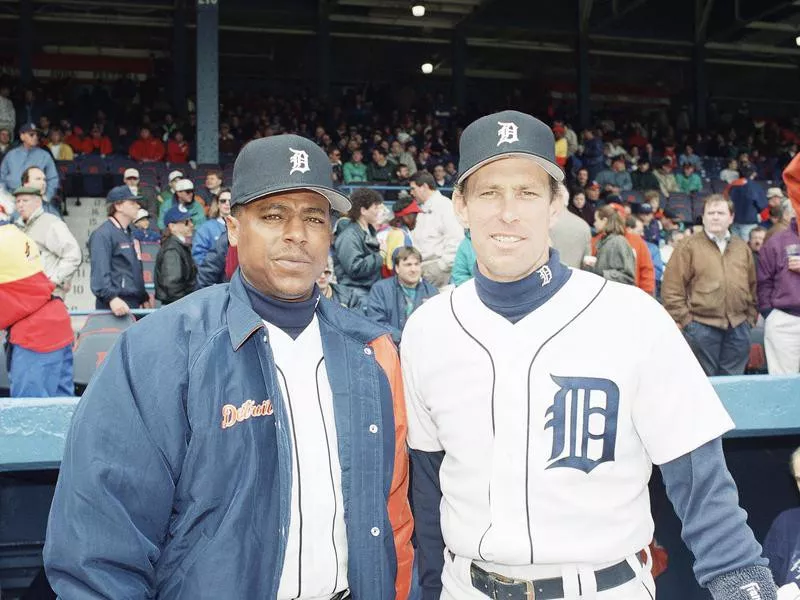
0, 76, 800, 395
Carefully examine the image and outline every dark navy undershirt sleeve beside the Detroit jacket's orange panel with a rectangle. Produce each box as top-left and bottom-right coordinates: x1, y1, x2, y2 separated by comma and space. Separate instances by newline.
409, 450, 444, 600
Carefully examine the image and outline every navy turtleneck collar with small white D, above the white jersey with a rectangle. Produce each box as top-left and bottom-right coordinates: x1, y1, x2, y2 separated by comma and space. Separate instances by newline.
475, 248, 572, 323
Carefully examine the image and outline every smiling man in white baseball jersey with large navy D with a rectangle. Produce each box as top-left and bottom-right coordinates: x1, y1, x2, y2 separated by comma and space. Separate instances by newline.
402, 111, 776, 600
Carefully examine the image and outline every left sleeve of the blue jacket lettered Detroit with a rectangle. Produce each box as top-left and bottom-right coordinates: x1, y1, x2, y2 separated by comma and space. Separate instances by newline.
44, 332, 189, 599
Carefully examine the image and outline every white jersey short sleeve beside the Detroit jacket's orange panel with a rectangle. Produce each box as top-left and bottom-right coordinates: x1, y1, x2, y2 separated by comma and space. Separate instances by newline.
400, 316, 443, 452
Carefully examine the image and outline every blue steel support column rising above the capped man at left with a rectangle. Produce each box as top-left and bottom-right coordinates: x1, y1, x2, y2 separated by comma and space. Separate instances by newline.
196, 0, 219, 164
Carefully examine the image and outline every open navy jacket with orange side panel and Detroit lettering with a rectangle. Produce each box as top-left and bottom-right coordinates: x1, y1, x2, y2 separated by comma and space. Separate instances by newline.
44, 271, 413, 600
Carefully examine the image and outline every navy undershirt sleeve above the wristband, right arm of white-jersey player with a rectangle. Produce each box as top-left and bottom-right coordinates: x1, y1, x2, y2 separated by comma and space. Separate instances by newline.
661, 438, 767, 587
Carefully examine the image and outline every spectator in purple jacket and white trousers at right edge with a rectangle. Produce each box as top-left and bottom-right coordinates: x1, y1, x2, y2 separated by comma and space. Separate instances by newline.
757, 218, 800, 375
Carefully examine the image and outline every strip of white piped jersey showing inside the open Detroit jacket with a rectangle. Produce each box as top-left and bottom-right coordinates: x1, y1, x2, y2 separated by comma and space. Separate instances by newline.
264, 315, 347, 600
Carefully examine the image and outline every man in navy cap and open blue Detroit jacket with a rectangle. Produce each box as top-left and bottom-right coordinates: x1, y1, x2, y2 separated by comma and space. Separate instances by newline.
44, 135, 413, 600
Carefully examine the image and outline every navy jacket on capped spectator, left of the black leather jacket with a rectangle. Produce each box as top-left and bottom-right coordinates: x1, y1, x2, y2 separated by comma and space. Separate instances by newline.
89, 218, 148, 308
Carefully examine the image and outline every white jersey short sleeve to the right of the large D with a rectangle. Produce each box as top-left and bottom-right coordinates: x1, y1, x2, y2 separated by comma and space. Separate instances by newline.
632, 299, 734, 465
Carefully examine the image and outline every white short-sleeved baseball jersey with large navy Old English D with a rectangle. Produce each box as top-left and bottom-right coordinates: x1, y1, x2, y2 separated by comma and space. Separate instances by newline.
402, 271, 733, 565
